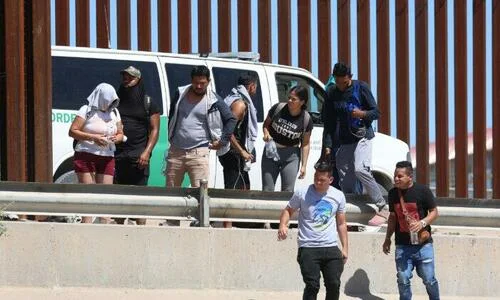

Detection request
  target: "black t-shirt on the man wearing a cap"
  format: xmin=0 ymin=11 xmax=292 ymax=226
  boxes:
xmin=115 ymin=81 xmax=160 ymax=158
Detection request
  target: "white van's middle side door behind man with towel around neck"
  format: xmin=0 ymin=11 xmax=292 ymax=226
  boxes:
xmin=207 ymin=60 xmax=271 ymax=190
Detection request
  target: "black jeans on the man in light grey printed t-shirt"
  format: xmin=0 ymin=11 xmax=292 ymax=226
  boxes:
xmin=297 ymin=247 xmax=344 ymax=300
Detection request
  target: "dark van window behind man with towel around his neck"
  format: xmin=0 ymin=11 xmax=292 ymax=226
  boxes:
xmin=212 ymin=67 xmax=264 ymax=122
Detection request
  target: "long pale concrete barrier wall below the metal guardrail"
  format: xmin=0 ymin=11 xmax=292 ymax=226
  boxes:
xmin=0 ymin=223 xmax=500 ymax=296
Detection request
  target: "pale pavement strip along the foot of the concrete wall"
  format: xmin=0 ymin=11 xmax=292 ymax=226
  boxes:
xmin=0 ymin=287 xmax=500 ymax=300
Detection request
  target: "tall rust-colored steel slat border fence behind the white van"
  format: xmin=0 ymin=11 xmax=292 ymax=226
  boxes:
xmin=0 ymin=0 xmax=500 ymax=199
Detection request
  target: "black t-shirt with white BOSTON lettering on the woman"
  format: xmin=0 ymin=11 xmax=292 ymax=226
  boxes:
xmin=267 ymin=104 xmax=313 ymax=146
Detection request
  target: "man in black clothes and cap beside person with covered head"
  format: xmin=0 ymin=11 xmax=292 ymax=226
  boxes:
xmin=115 ymin=66 xmax=160 ymax=225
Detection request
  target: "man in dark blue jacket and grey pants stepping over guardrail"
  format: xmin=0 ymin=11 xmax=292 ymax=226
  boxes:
xmin=323 ymin=63 xmax=389 ymax=226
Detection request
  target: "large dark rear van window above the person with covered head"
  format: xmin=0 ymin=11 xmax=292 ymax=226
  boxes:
xmin=52 ymin=56 xmax=163 ymax=114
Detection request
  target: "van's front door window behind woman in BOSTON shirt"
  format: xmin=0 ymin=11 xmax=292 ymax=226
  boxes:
xmin=275 ymin=73 xmax=326 ymax=125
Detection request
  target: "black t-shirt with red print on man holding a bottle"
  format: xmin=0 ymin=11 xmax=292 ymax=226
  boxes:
xmin=388 ymin=183 xmax=436 ymax=245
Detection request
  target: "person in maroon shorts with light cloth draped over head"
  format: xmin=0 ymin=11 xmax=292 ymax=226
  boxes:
xmin=69 ymin=83 xmax=123 ymax=223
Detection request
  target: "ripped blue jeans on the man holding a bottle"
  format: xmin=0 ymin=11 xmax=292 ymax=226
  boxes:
xmin=395 ymin=243 xmax=439 ymax=300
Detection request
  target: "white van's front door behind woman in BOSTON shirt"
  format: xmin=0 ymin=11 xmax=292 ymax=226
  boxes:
xmin=266 ymin=66 xmax=326 ymax=190
